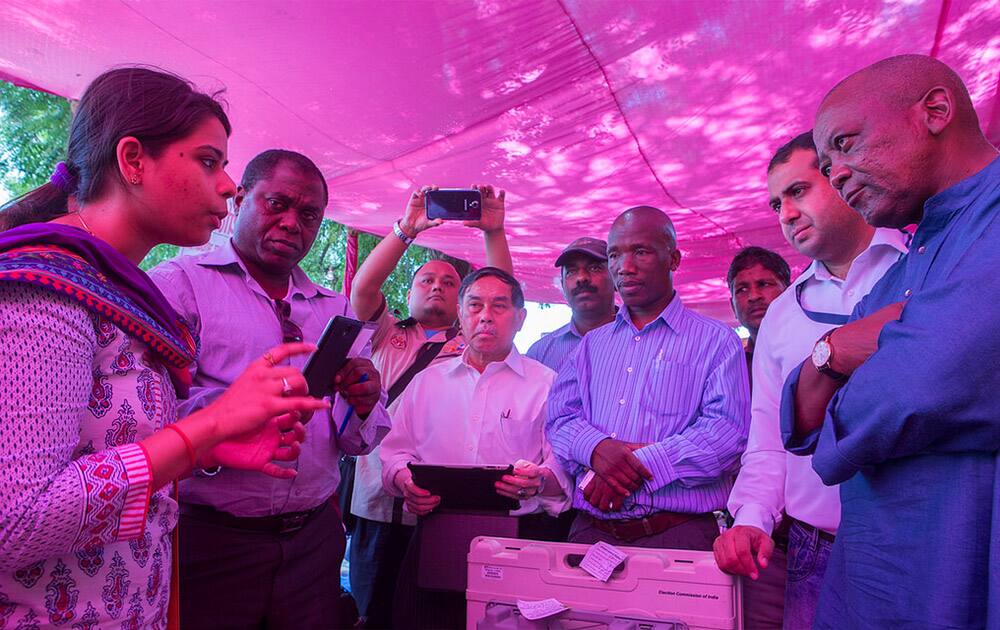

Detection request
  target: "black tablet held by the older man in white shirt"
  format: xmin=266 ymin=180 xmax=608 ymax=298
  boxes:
xmin=407 ymin=462 xmax=520 ymax=512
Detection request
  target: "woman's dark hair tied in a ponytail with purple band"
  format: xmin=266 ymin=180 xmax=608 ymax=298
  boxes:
xmin=0 ymin=67 xmax=232 ymax=228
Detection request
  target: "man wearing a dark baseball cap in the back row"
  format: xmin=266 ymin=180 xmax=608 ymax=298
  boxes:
xmin=527 ymin=236 xmax=616 ymax=372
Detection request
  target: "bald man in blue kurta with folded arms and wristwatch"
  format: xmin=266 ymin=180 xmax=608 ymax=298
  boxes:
xmin=782 ymin=55 xmax=1000 ymax=629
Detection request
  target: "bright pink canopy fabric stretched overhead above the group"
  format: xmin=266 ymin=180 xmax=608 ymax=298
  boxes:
xmin=0 ymin=0 xmax=1000 ymax=321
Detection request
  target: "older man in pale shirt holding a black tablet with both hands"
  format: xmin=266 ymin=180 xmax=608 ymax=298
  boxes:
xmin=380 ymin=267 xmax=572 ymax=628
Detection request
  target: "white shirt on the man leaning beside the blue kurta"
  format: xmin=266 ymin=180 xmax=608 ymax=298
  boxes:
xmin=728 ymin=229 xmax=907 ymax=534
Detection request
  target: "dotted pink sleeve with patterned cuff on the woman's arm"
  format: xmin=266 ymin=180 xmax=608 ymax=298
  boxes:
xmin=0 ymin=283 xmax=152 ymax=572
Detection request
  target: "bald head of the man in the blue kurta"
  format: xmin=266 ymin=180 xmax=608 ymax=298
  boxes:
xmin=813 ymin=55 xmax=996 ymax=228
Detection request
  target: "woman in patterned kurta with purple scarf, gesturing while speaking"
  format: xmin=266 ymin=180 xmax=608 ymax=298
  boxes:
xmin=0 ymin=68 xmax=325 ymax=629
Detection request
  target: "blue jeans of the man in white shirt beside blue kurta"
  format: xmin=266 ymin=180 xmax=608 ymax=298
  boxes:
xmin=784 ymin=523 xmax=833 ymax=630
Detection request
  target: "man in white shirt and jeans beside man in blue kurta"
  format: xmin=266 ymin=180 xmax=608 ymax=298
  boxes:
xmin=715 ymin=132 xmax=906 ymax=630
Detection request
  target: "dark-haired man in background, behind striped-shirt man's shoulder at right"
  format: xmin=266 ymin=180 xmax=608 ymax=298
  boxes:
xmin=726 ymin=246 xmax=792 ymax=389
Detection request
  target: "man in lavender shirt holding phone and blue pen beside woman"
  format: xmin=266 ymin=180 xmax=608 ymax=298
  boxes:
xmin=151 ymin=150 xmax=390 ymax=629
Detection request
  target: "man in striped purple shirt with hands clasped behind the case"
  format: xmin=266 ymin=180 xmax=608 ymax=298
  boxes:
xmin=546 ymin=206 xmax=750 ymax=551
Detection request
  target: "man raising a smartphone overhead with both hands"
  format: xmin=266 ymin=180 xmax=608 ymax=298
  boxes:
xmin=350 ymin=185 xmax=513 ymax=628
